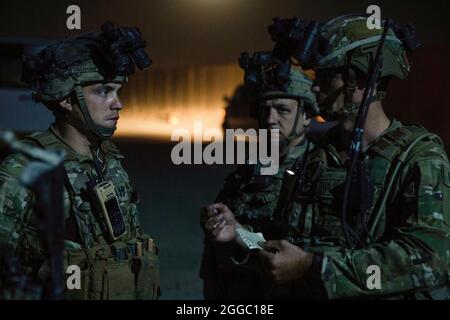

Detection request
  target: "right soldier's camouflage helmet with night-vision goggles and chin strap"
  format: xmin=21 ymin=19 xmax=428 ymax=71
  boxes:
xmin=269 ymin=14 xmax=420 ymax=120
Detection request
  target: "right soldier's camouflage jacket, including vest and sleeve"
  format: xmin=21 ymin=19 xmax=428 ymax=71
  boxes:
xmin=298 ymin=120 xmax=450 ymax=299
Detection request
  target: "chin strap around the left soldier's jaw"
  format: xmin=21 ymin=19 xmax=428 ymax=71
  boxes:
xmin=68 ymin=85 xmax=115 ymax=144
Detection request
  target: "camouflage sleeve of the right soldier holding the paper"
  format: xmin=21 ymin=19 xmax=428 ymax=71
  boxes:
xmin=320 ymin=157 xmax=450 ymax=299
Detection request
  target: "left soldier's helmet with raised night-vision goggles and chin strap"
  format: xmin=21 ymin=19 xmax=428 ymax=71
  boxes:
xmin=22 ymin=22 xmax=151 ymax=140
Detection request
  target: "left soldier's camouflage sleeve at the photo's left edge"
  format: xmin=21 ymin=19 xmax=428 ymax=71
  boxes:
xmin=0 ymin=155 xmax=32 ymax=247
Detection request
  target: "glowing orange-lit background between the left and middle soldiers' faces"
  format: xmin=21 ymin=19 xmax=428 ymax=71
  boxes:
xmin=117 ymin=64 xmax=242 ymax=140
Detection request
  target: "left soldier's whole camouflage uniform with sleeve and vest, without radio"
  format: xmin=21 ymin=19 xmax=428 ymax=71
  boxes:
xmin=0 ymin=127 xmax=159 ymax=299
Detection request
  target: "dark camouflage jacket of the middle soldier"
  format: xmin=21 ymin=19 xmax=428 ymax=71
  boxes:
xmin=200 ymin=141 xmax=308 ymax=299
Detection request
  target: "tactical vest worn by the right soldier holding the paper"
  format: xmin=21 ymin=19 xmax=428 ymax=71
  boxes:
xmin=289 ymin=122 xmax=442 ymax=251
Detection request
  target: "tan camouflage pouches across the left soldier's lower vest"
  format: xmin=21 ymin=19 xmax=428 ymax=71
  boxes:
xmin=64 ymin=236 xmax=159 ymax=300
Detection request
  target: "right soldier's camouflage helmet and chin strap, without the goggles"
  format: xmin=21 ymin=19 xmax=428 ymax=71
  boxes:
xmin=314 ymin=15 xmax=419 ymax=120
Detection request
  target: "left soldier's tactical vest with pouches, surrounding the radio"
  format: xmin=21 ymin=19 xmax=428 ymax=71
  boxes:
xmin=18 ymin=132 xmax=159 ymax=300
